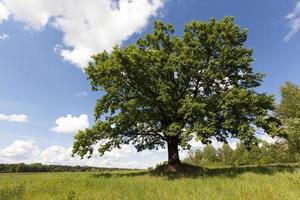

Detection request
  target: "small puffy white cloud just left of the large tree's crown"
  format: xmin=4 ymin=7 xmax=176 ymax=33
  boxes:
xmin=51 ymin=114 xmax=89 ymax=133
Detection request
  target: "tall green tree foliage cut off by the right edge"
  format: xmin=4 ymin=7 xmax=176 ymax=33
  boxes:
xmin=276 ymin=83 xmax=300 ymax=154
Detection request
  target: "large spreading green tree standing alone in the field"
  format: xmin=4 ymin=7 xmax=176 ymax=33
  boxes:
xmin=73 ymin=17 xmax=276 ymax=165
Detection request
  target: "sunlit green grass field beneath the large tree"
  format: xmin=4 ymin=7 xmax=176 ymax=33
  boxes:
xmin=0 ymin=165 xmax=300 ymax=200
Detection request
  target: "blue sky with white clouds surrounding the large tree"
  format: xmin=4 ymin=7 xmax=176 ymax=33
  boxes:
xmin=0 ymin=0 xmax=300 ymax=168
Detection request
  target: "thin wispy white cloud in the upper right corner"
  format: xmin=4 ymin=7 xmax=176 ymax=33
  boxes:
xmin=284 ymin=1 xmax=300 ymax=42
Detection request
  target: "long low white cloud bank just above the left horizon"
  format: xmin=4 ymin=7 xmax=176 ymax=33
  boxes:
xmin=0 ymin=140 xmax=167 ymax=168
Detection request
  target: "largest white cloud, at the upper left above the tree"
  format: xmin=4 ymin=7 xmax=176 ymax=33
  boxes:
xmin=2 ymin=0 xmax=165 ymax=68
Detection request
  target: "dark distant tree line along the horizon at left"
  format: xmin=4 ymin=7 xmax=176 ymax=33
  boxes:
xmin=0 ymin=163 xmax=132 ymax=173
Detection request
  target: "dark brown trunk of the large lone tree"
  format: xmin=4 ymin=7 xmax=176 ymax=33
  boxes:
xmin=168 ymin=136 xmax=181 ymax=166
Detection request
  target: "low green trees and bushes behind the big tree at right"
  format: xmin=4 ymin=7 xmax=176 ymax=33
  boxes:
xmin=184 ymin=141 xmax=300 ymax=166
